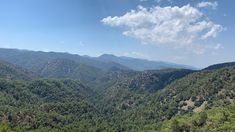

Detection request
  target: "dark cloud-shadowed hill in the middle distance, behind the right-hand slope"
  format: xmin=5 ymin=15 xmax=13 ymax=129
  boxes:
xmin=114 ymin=69 xmax=194 ymax=92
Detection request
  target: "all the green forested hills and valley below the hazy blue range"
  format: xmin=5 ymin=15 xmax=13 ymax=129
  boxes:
xmin=0 ymin=51 xmax=235 ymax=132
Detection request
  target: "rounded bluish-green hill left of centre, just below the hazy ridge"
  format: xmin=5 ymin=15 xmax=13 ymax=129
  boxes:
xmin=36 ymin=59 xmax=104 ymax=82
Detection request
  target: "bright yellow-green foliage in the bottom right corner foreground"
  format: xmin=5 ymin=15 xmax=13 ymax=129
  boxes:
xmin=159 ymin=104 xmax=235 ymax=132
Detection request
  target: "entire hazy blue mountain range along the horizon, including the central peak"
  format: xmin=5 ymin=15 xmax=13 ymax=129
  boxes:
xmin=0 ymin=48 xmax=195 ymax=71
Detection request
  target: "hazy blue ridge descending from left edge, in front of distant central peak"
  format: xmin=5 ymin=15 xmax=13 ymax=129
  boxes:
xmin=0 ymin=48 xmax=128 ymax=70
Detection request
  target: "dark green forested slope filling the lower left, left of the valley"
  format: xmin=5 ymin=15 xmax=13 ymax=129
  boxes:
xmin=0 ymin=79 xmax=115 ymax=131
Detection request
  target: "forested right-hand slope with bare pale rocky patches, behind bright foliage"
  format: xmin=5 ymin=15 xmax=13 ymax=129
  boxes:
xmin=100 ymin=67 xmax=235 ymax=131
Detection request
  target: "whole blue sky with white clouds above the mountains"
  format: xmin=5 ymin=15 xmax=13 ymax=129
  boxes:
xmin=0 ymin=0 xmax=235 ymax=67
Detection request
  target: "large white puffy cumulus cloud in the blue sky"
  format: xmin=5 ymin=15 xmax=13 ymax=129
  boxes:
xmin=101 ymin=4 xmax=224 ymax=54
